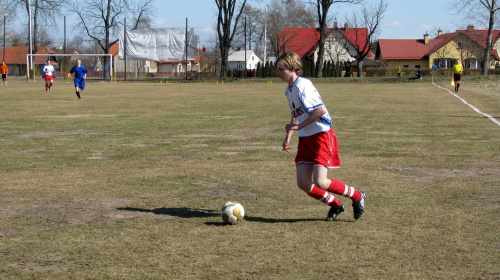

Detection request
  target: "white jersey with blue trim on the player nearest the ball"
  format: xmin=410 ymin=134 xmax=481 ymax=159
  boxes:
xmin=285 ymin=77 xmax=332 ymax=137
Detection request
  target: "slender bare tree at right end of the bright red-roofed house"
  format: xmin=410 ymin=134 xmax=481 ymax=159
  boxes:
xmin=346 ymin=0 xmax=388 ymax=77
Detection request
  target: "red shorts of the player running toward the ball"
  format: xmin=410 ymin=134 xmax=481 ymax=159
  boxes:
xmin=295 ymin=128 xmax=340 ymax=168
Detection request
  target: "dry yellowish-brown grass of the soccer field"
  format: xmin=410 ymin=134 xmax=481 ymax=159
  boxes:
xmin=0 ymin=77 xmax=500 ymax=279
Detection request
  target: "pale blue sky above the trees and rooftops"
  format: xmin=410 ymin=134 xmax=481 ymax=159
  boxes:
xmin=155 ymin=0 xmax=470 ymax=44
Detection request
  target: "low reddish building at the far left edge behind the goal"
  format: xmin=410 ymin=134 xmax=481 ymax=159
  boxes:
xmin=0 ymin=46 xmax=57 ymax=76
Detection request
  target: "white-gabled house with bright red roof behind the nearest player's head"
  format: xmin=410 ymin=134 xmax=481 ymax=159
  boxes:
xmin=279 ymin=22 xmax=373 ymax=67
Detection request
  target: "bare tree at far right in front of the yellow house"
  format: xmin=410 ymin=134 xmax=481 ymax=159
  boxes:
xmin=452 ymin=0 xmax=500 ymax=75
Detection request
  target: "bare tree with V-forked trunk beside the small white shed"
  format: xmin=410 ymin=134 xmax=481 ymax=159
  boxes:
xmin=215 ymin=0 xmax=247 ymax=78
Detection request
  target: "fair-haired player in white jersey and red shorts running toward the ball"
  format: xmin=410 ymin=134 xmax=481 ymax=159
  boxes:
xmin=277 ymin=52 xmax=365 ymax=221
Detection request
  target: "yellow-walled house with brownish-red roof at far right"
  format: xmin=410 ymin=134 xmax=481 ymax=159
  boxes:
xmin=376 ymin=25 xmax=500 ymax=70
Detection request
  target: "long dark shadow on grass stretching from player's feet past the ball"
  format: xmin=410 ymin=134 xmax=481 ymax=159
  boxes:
xmin=117 ymin=207 xmax=350 ymax=225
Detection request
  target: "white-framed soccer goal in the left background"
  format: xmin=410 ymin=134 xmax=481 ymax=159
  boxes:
xmin=26 ymin=53 xmax=114 ymax=82
